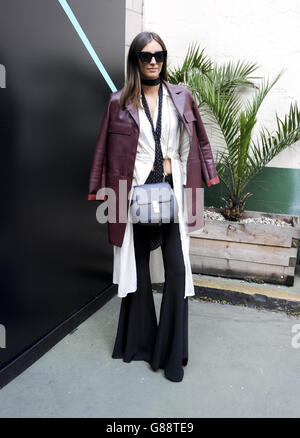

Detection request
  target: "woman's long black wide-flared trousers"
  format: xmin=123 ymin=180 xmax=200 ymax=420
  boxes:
xmin=112 ymin=219 xmax=188 ymax=382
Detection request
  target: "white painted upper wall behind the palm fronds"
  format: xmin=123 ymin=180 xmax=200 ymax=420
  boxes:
xmin=143 ymin=0 xmax=300 ymax=169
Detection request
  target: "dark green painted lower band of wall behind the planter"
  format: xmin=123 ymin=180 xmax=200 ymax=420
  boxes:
xmin=204 ymin=167 xmax=300 ymax=264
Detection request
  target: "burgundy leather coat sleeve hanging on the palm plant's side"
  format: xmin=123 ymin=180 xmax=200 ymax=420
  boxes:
xmin=191 ymin=94 xmax=220 ymax=187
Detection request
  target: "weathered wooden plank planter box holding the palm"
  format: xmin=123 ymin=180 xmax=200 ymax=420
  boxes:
xmin=190 ymin=207 xmax=300 ymax=286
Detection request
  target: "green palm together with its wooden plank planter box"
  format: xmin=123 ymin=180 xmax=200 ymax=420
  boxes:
xmin=168 ymin=45 xmax=300 ymax=285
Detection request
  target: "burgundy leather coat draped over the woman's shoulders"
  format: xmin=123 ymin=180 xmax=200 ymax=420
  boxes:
xmin=88 ymin=80 xmax=220 ymax=247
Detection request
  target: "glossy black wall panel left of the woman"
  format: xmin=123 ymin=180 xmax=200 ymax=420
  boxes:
xmin=0 ymin=0 xmax=125 ymax=371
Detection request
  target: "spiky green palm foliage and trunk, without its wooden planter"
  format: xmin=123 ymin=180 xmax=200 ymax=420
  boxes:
xmin=168 ymin=44 xmax=300 ymax=220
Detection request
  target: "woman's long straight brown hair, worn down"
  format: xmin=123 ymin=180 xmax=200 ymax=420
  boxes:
xmin=119 ymin=32 xmax=168 ymax=109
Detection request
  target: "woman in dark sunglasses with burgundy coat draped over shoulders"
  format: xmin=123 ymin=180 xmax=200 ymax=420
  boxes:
xmin=89 ymin=32 xmax=219 ymax=382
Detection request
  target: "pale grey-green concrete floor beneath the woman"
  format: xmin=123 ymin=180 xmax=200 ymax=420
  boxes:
xmin=0 ymin=293 xmax=300 ymax=418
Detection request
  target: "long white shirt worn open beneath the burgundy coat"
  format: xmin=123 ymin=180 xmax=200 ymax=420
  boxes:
xmin=113 ymin=85 xmax=195 ymax=298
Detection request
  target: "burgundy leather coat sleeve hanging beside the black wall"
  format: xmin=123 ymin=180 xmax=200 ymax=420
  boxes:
xmin=88 ymin=94 xmax=112 ymax=201
